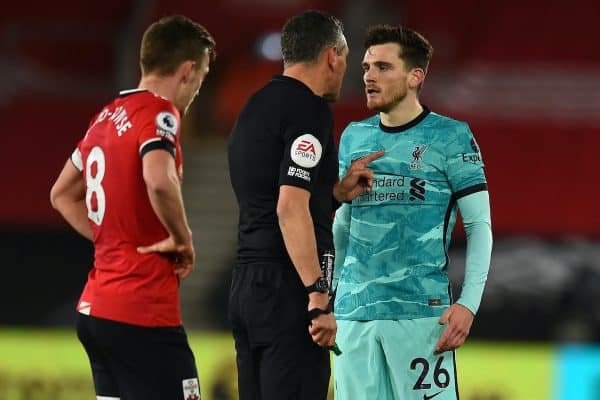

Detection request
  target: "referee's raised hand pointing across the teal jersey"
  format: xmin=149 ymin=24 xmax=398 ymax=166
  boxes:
xmin=333 ymin=150 xmax=385 ymax=202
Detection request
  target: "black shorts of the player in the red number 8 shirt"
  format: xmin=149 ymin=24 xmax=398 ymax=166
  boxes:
xmin=77 ymin=314 xmax=200 ymax=400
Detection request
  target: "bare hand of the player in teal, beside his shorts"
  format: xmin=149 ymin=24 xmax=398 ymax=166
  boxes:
xmin=433 ymin=303 xmax=475 ymax=354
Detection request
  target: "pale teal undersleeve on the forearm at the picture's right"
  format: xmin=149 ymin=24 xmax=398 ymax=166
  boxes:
xmin=457 ymin=191 xmax=492 ymax=314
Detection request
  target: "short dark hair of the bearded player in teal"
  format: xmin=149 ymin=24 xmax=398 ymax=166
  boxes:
xmin=365 ymin=25 xmax=433 ymax=72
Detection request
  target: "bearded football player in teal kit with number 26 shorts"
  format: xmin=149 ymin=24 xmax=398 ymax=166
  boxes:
xmin=334 ymin=25 xmax=492 ymax=400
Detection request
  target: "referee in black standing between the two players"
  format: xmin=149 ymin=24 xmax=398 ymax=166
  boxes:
xmin=229 ymin=11 xmax=383 ymax=400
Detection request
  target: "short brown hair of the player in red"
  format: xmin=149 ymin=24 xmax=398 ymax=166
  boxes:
xmin=140 ymin=15 xmax=216 ymax=75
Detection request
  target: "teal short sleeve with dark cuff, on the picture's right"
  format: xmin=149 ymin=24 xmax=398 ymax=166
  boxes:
xmin=446 ymin=122 xmax=487 ymax=198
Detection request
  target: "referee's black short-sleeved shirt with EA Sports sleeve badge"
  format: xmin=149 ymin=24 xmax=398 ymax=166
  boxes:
xmin=229 ymin=75 xmax=338 ymax=263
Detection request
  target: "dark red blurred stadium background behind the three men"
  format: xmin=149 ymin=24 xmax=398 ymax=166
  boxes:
xmin=0 ymin=0 xmax=600 ymax=342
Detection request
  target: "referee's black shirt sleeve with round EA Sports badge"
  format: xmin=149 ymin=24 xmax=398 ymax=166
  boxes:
xmin=279 ymin=100 xmax=333 ymax=192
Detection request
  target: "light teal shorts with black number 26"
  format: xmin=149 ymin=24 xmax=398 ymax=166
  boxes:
xmin=333 ymin=317 xmax=458 ymax=400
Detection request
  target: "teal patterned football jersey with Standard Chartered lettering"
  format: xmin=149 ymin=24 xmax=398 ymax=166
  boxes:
xmin=335 ymin=109 xmax=487 ymax=320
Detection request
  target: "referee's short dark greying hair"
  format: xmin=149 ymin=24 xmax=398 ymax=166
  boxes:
xmin=281 ymin=10 xmax=346 ymax=67
